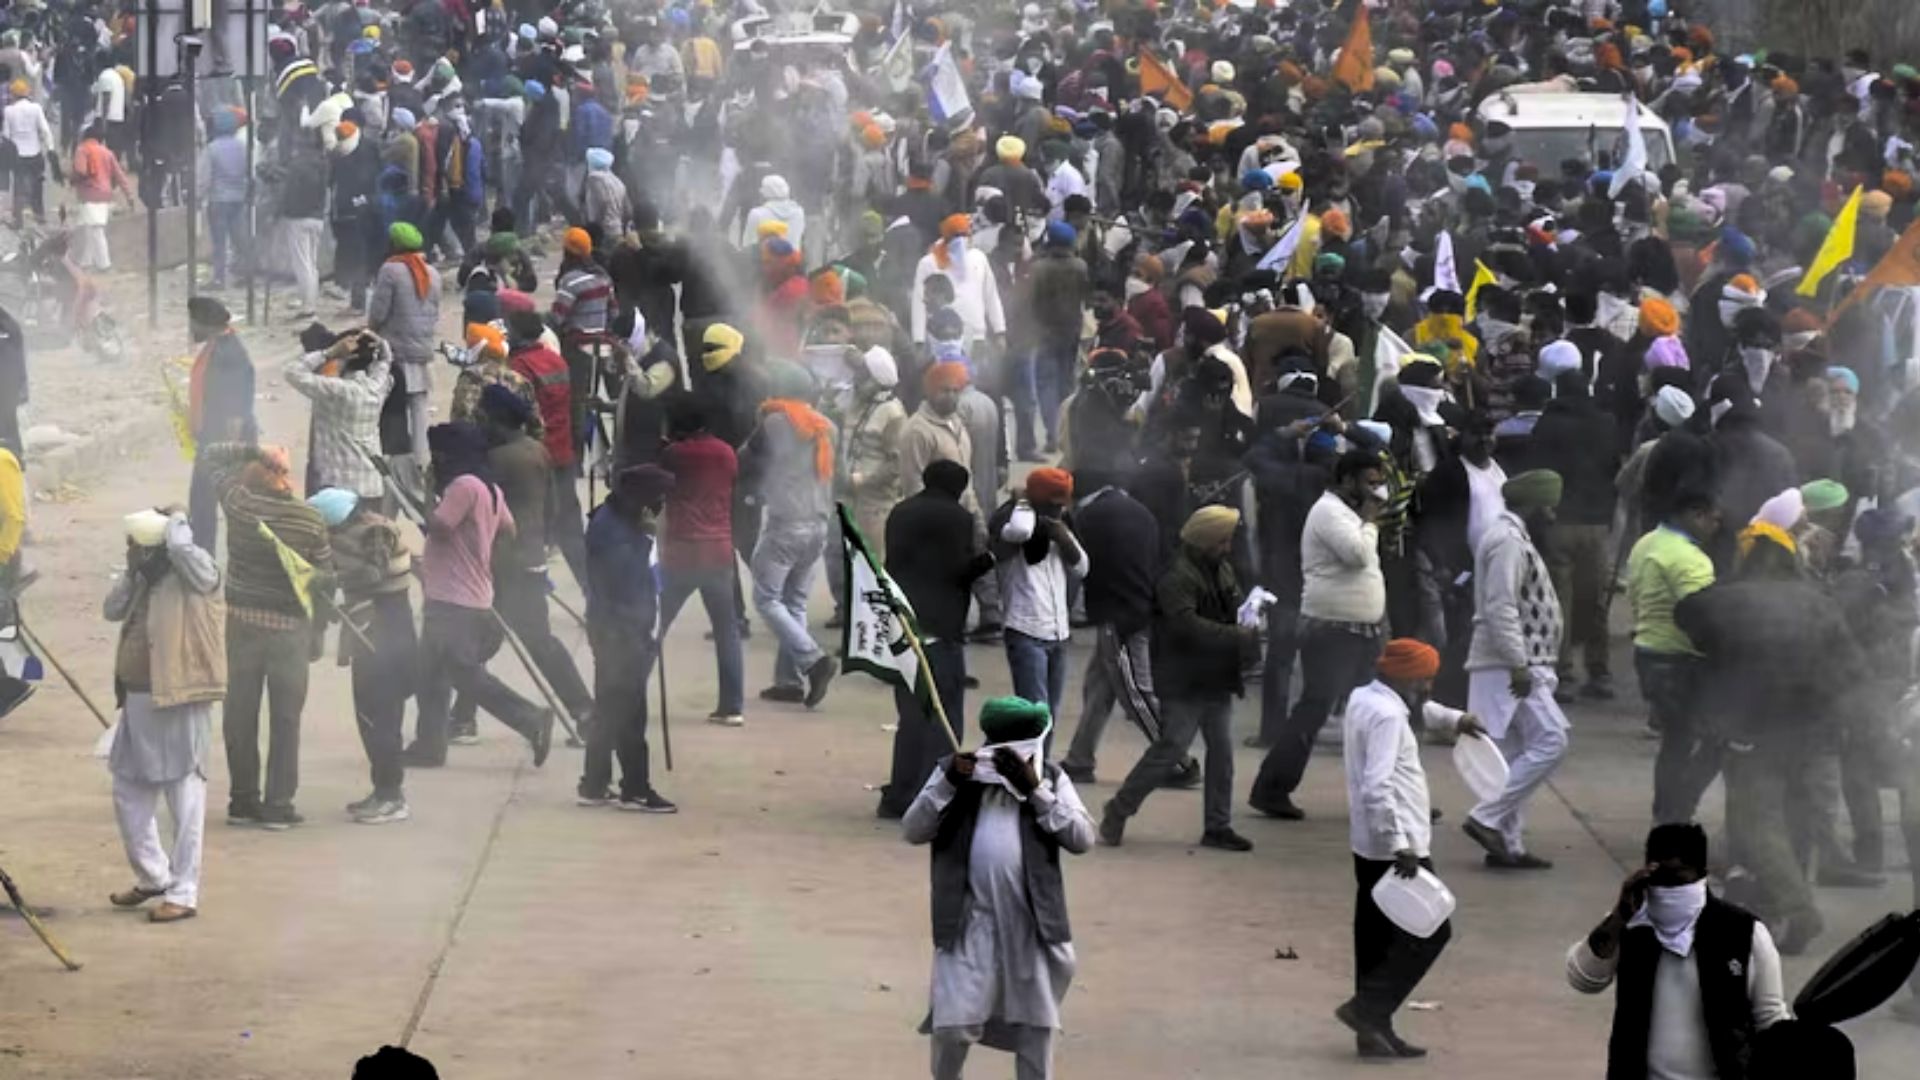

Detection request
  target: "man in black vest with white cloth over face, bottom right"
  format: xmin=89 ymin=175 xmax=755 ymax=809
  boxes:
xmin=1567 ymin=824 xmax=1789 ymax=1076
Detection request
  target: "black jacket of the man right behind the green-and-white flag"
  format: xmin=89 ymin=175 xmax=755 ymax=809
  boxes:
xmin=887 ymin=488 xmax=993 ymax=640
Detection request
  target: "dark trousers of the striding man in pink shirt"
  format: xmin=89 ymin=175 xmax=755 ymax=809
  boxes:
xmin=415 ymin=600 xmax=545 ymax=761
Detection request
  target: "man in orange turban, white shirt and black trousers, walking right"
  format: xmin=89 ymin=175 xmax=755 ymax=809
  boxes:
xmin=1334 ymin=638 xmax=1486 ymax=1059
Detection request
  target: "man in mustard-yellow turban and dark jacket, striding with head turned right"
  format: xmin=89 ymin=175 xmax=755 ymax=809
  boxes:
xmin=1100 ymin=505 xmax=1260 ymax=851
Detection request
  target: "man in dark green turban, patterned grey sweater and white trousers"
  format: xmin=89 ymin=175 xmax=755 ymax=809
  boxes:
xmin=1461 ymin=469 xmax=1567 ymax=871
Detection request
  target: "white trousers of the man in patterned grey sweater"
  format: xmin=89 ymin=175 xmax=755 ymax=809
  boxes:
xmin=1467 ymin=667 xmax=1567 ymax=855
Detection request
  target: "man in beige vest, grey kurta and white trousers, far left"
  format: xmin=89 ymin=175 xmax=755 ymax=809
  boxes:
xmin=104 ymin=509 xmax=227 ymax=922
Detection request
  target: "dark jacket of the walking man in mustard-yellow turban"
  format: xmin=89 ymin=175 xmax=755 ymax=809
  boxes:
xmin=1154 ymin=544 xmax=1258 ymax=698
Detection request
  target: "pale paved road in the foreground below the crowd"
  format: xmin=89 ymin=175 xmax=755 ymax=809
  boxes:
xmin=0 ymin=282 xmax=1920 ymax=1080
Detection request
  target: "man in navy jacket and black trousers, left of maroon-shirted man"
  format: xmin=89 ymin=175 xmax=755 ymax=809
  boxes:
xmin=580 ymin=465 xmax=680 ymax=813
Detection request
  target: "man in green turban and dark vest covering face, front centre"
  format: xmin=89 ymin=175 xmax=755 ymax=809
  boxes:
xmin=900 ymin=698 xmax=1092 ymax=1080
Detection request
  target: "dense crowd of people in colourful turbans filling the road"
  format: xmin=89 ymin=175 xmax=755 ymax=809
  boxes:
xmin=0 ymin=0 xmax=1920 ymax=1078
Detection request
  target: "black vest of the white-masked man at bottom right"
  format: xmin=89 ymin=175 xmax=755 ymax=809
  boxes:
xmin=1607 ymin=896 xmax=1755 ymax=1080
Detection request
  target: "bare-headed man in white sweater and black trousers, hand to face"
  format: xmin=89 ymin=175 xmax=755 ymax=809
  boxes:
xmin=1248 ymin=450 xmax=1390 ymax=821
